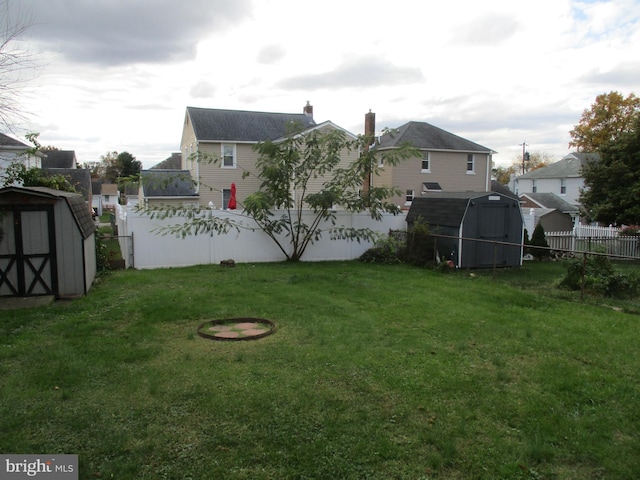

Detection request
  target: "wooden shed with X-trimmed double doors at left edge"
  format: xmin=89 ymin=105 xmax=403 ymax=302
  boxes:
xmin=0 ymin=187 xmax=97 ymax=298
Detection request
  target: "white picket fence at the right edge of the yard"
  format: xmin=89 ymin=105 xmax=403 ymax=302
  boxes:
xmin=545 ymin=225 xmax=640 ymax=258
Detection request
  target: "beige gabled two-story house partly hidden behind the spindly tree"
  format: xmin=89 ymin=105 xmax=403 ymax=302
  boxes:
xmin=180 ymin=103 xmax=359 ymax=209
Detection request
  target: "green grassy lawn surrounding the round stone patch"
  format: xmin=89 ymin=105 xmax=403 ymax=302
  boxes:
xmin=0 ymin=262 xmax=640 ymax=480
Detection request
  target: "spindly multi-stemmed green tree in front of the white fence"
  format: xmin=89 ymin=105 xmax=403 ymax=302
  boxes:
xmin=150 ymin=126 xmax=420 ymax=261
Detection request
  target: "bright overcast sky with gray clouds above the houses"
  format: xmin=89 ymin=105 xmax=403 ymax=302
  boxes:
xmin=8 ymin=0 xmax=640 ymax=168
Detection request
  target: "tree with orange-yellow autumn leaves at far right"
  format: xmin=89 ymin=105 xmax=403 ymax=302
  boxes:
xmin=569 ymin=91 xmax=640 ymax=153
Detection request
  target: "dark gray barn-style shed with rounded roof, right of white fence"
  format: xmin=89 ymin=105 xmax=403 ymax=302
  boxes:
xmin=407 ymin=192 xmax=524 ymax=268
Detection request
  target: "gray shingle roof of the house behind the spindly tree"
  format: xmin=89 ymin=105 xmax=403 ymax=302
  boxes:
xmin=187 ymin=107 xmax=316 ymax=142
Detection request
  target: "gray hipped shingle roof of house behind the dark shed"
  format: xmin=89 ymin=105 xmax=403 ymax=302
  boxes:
xmin=377 ymin=122 xmax=493 ymax=153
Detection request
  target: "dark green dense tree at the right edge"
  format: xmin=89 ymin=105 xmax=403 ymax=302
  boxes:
xmin=580 ymin=116 xmax=640 ymax=225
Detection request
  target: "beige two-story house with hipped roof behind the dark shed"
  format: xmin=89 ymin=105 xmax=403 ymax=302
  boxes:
xmin=371 ymin=122 xmax=496 ymax=209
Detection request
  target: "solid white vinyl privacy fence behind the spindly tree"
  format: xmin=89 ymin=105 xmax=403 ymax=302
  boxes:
xmin=116 ymin=206 xmax=406 ymax=269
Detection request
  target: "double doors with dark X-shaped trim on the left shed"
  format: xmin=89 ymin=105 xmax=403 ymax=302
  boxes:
xmin=0 ymin=206 xmax=57 ymax=297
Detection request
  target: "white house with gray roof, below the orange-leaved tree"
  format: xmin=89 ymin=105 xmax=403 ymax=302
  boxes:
xmin=510 ymin=153 xmax=600 ymax=208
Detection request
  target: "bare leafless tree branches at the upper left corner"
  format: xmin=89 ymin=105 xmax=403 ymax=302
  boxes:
xmin=0 ymin=0 xmax=36 ymax=131
